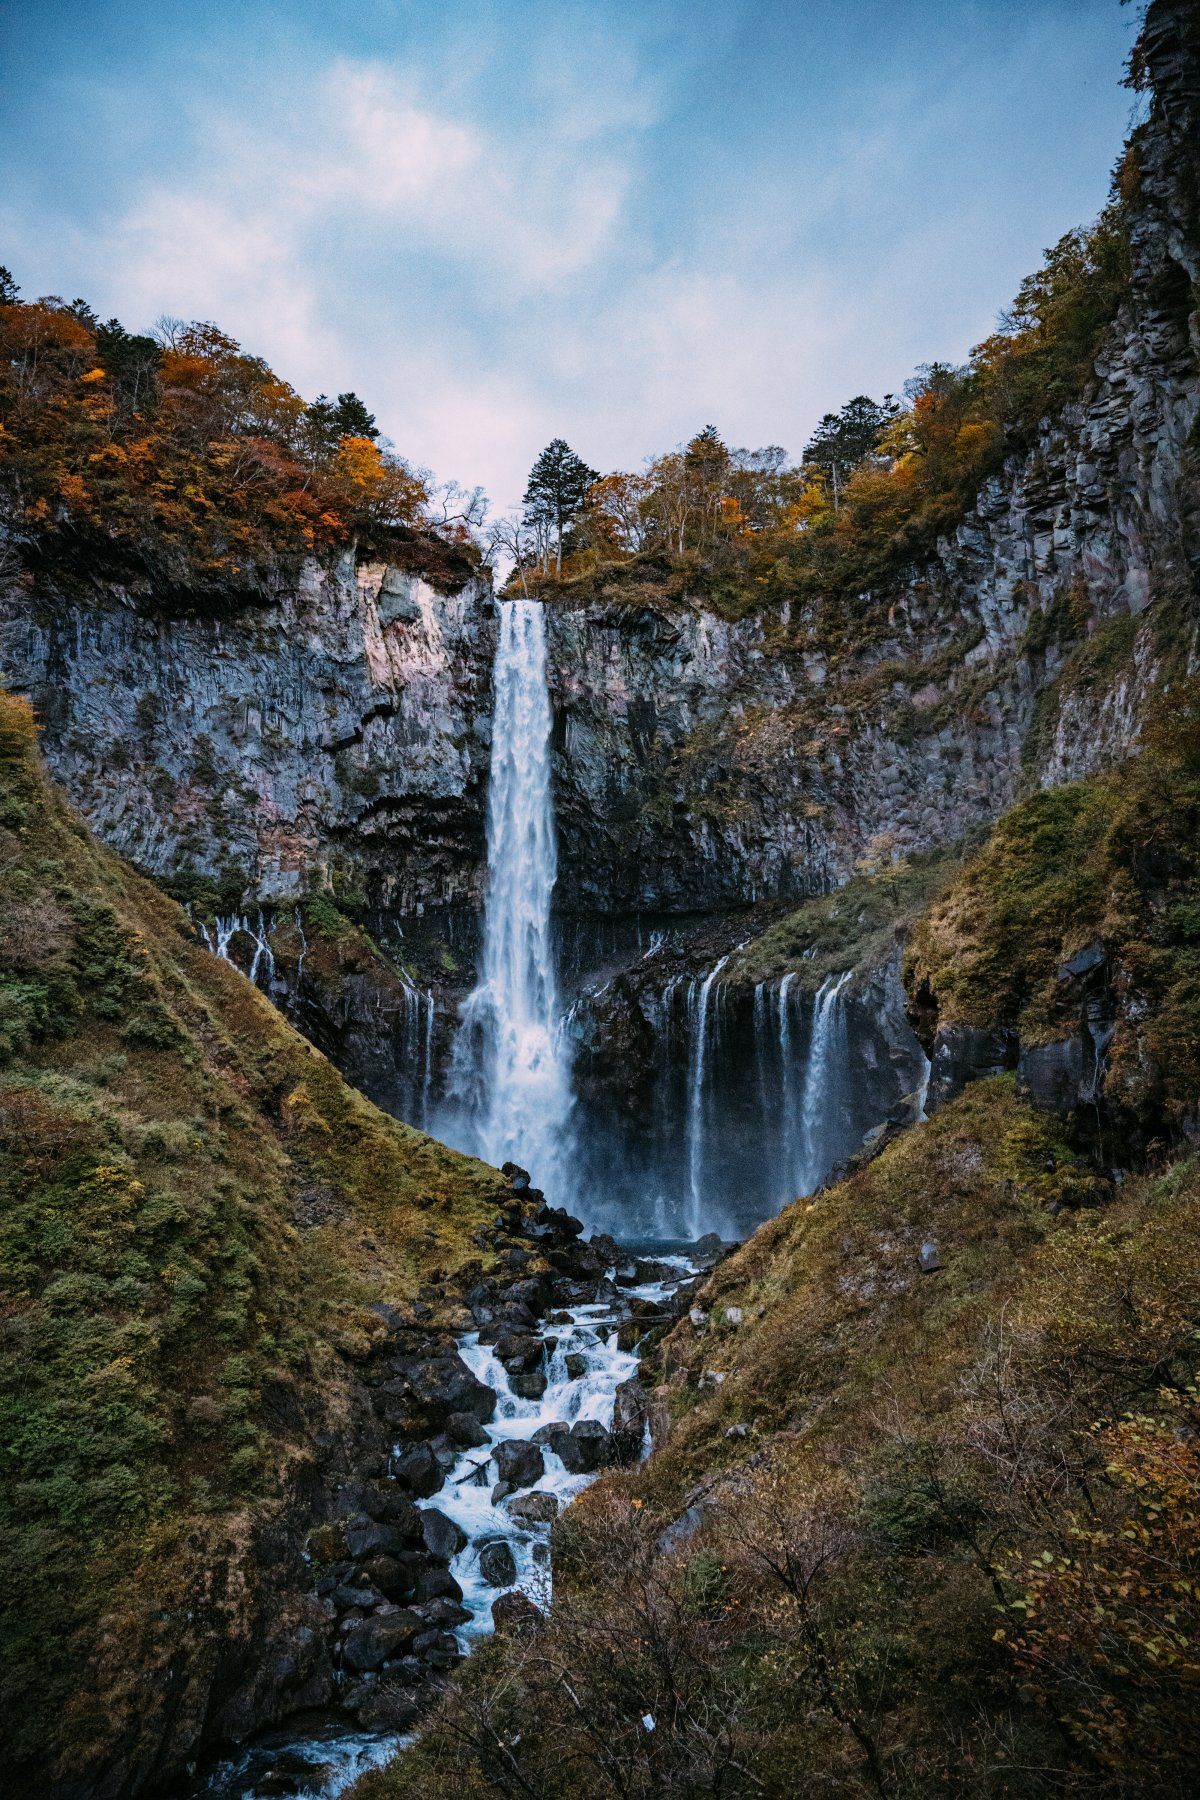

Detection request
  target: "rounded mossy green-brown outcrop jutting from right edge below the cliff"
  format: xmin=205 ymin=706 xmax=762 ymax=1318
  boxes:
xmin=905 ymin=682 xmax=1200 ymax=1127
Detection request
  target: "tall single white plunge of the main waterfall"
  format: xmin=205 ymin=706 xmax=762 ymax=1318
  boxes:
xmin=450 ymin=599 xmax=572 ymax=1199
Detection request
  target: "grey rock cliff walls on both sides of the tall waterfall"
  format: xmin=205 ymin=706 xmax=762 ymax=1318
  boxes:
xmin=0 ymin=7 xmax=1200 ymax=1224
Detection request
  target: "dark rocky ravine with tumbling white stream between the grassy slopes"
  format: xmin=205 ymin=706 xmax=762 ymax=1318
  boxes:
xmin=184 ymin=1170 xmax=698 ymax=1791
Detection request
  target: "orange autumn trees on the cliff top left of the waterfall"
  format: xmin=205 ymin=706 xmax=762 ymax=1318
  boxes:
xmin=0 ymin=280 xmax=482 ymax=607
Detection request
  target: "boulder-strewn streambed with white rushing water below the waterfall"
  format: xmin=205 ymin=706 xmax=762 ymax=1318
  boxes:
xmin=193 ymin=1165 xmax=708 ymax=1800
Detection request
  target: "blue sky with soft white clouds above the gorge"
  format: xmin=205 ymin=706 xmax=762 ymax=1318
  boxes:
xmin=0 ymin=0 xmax=1137 ymax=511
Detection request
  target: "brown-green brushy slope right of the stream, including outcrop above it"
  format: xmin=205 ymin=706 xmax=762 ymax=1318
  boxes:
xmin=358 ymin=709 xmax=1200 ymax=1800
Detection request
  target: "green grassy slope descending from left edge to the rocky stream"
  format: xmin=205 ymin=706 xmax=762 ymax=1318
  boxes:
xmin=0 ymin=697 xmax=507 ymax=1766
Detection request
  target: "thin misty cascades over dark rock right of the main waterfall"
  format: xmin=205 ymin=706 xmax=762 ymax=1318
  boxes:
xmin=574 ymin=968 xmax=925 ymax=1242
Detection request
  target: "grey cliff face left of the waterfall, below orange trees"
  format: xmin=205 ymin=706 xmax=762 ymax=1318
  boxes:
xmin=0 ymin=554 xmax=495 ymax=913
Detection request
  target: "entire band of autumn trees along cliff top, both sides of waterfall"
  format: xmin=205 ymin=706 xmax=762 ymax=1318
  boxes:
xmin=0 ymin=174 xmax=1137 ymax=610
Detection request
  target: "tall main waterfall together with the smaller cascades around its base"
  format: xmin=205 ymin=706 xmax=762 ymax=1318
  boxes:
xmin=198 ymin=599 xmax=928 ymax=1242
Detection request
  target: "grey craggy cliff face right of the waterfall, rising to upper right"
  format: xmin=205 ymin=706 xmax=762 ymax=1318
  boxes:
xmin=551 ymin=58 xmax=1200 ymax=913
